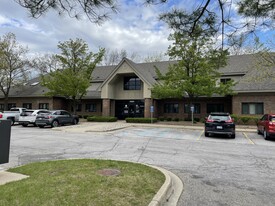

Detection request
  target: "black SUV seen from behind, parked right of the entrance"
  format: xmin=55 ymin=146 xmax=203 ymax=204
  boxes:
xmin=204 ymin=113 xmax=236 ymax=138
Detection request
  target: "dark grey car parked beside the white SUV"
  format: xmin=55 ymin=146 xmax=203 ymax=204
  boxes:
xmin=35 ymin=110 xmax=79 ymax=128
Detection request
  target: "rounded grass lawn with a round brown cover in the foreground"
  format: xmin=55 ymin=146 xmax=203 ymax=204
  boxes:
xmin=0 ymin=159 xmax=165 ymax=206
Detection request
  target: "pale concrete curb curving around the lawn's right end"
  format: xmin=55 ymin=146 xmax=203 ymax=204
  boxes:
xmin=148 ymin=165 xmax=183 ymax=206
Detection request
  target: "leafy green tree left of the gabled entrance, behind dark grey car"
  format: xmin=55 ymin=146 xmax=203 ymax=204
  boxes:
xmin=42 ymin=39 xmax=104 ymax=113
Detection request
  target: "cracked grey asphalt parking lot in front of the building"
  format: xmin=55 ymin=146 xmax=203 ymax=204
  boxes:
xmin=0 ymin=124 xmax=275 ymax=206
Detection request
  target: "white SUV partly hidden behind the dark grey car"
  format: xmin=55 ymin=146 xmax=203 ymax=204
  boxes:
xmin=18 ymin=109 xmax=50 ymax=127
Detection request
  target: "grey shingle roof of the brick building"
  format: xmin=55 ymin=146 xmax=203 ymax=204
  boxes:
xmin=1 ymin=55 xmax=275 ymax=99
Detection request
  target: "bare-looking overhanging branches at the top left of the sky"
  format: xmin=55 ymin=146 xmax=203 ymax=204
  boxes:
xmin=15 ymin=0 xmax=117 ymax=24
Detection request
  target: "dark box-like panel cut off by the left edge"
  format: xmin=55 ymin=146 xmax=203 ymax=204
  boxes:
xmin=0 ymin=120 xmax=11 ymax=164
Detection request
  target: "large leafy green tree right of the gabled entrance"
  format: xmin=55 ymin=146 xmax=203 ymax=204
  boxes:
xmin=152 ymin=28 xmax=233 ymax=116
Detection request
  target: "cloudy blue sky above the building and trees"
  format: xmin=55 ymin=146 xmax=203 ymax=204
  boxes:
xmin=0 ymin=0 xmax=274 ymax=61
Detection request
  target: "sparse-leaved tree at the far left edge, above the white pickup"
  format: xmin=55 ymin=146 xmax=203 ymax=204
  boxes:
xmin=0 ymin=33 xmax=30 ymax=110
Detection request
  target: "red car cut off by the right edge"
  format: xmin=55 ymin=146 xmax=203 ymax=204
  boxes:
xmin=257 ymin=114 xmax=275 ymax=140
